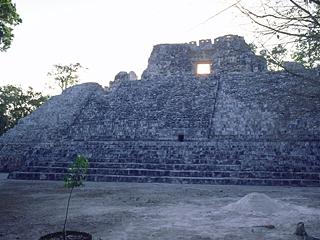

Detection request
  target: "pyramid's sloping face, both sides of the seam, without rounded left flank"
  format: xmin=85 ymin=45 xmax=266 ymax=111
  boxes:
xmin=69 ymin=71 xmax=320 ymax=140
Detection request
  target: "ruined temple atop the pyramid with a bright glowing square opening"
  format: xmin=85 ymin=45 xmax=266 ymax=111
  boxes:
xmin=142 ymin=35 xmax=267 ymax=79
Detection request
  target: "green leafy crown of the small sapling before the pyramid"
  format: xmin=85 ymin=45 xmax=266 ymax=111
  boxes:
xmin=64 ymin=155 xmax=89 ymax=188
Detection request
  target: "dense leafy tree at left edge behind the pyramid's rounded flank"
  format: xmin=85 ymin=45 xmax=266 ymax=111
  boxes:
xmin=0 ymin=85 xmax=48 ymax=135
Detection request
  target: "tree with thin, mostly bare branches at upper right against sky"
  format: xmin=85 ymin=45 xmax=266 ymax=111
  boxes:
xmin=238 ymin=0 xmax=320 ymax=68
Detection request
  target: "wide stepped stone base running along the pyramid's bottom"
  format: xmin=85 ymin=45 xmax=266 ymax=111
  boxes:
xmin=9 ymin=140 xmax=320 ymax=186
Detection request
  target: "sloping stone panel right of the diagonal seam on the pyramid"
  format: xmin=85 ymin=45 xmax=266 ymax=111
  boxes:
xmin=213 ymin=71 xmax=320 ymax=139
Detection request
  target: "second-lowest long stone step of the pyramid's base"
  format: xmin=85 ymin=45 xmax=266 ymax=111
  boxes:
xmin=25 ymin=167 xmax=320 ymax=180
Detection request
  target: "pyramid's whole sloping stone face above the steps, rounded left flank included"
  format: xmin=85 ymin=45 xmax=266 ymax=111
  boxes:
xmin=0 ymin=67 xmax=320 ymax=170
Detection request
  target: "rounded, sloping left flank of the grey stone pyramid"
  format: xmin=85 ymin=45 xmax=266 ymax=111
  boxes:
xmin=0 ymin=83 xmax=103 ymax=171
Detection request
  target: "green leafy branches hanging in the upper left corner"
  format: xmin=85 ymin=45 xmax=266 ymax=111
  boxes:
xmin=0 ymin=0 xmax=22 ymax=51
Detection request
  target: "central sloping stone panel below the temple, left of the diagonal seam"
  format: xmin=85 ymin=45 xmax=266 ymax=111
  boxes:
xmin=70 ymin=75 xmax=217 ymax=140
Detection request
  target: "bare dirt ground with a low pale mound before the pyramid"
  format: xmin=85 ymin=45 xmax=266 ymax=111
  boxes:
xmin=0 ymin=174 xmax=320 ymax=240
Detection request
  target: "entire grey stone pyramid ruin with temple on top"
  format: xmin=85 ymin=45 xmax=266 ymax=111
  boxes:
xmin=0 ymin=35 xmax=320 ymax=186
